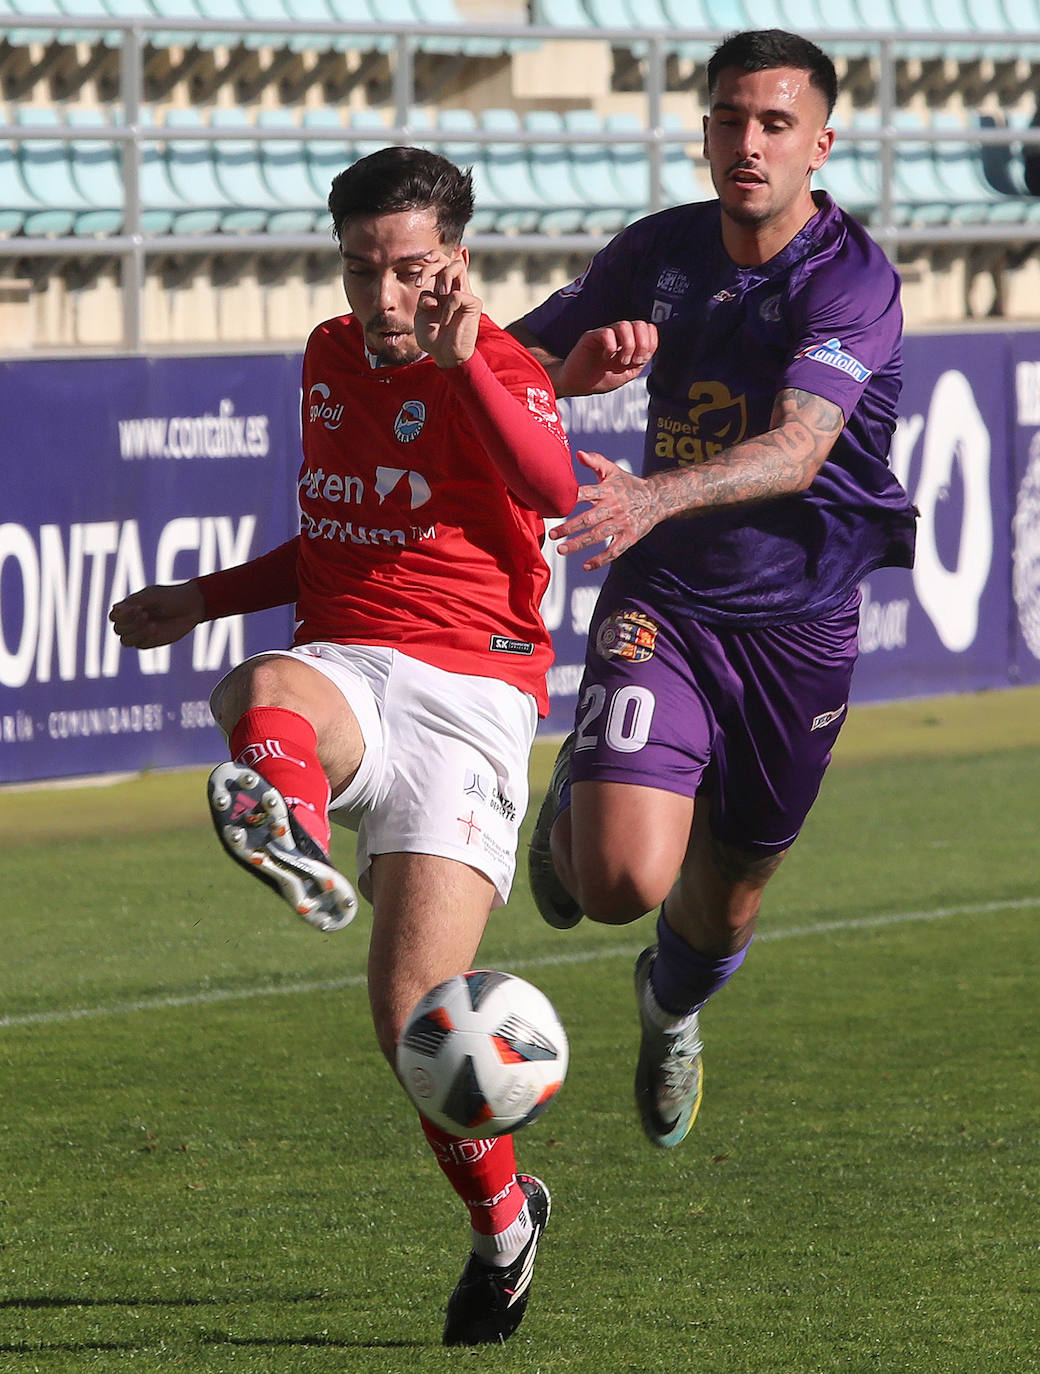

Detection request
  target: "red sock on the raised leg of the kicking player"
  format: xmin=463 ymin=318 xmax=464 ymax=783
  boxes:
xmin=228 ymin=706 xmax=331 ymax=853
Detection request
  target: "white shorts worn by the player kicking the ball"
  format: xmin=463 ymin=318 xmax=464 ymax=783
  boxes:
xmin=212 ymin=643 xmax=539 ymax=907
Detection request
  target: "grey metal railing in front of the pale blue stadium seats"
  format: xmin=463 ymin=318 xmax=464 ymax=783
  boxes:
xmin=0 ymin=14 xmax=1040 ymax=352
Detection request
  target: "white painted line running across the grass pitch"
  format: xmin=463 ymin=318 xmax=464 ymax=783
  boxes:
xmin=0 ymin=896 xmax=1040 ymax=1031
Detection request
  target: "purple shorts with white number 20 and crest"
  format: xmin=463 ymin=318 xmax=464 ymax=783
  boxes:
xmin=570 ymin=577 xmax=860 ymax=855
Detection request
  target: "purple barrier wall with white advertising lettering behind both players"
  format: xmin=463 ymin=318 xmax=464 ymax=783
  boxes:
xmin=0 ymin=331 xmax=1040 ymax=783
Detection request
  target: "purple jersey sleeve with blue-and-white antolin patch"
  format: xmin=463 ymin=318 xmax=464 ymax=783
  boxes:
xmin=779 ymin=237 xmax=903 ymax=423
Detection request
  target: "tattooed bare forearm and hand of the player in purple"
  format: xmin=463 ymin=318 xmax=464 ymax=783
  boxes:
xmin=550 ymin=387 xmax=845 ymax=572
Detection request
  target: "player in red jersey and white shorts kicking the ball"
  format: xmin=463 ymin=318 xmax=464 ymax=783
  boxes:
xmin=111 ymin=147 xmax=577 ymax=1345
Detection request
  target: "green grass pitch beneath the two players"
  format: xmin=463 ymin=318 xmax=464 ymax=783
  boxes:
xmin=0 ymin=690 xmax=1040 ymax=1374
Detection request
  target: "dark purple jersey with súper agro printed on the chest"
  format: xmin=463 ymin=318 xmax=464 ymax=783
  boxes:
xmin=525 ymin=192 xmax=915 ymax=625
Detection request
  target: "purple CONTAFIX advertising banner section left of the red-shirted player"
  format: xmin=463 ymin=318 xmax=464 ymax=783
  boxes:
xmin=0 ymin=356 xmax=299 ymax=782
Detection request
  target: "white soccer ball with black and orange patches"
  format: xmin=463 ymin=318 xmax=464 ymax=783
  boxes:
xmin=397 ymin=970 xmax=570 ymax=1139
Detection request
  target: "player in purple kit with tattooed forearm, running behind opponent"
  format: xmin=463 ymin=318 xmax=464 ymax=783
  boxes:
xmin=511 ymin=29 xmax=916 ymax=1147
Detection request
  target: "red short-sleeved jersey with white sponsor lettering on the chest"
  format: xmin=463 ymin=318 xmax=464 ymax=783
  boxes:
xmin=294 ymin=315 xmax=577 ymax=714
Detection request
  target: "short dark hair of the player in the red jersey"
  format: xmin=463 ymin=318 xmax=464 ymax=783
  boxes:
xmin=328 ymin=147 xmax=473 ymax=247
